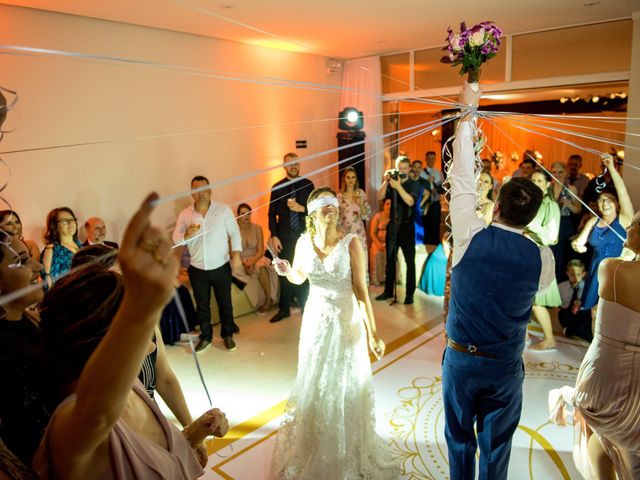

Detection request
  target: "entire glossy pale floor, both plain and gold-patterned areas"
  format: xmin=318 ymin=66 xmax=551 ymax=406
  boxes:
xmin=158 ymin=290 xmax=585 ymax=480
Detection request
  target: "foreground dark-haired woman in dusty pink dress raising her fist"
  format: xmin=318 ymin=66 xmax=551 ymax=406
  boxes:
xmin=32 ymin=194 xmax=229 ymax=480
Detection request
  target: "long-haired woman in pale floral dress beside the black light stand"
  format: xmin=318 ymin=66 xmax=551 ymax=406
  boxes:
xmin=337 ymin=167 xmax=371 ymax=258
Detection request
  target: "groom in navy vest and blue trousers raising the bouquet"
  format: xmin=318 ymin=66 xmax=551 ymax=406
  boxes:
xmin=442 ymin=83 xmax=554 ymax=480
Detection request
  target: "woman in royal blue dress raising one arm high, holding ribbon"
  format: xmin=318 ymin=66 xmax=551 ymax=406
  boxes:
xmin=572 ymin=154 xmax=633 ymax=318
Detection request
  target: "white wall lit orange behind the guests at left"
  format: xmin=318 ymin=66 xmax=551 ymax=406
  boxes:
xmin=0 ymin=5 xmax=340 ymax=248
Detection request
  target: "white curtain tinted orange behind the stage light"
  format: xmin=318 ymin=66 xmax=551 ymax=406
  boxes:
xmin=341 ymin=57 xmax=384 ymax=211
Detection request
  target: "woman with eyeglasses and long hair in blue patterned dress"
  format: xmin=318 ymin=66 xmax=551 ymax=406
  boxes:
xmin=42 ymin=207 xmax=82 ymax=288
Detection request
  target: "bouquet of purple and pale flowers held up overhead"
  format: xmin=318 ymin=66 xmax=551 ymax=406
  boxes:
xmin=440 ymin=22 xmax=502 ymax=83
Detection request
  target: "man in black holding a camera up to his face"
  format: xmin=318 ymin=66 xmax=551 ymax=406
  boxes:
xmin=376 ymin=157 xmax=420 ymax=305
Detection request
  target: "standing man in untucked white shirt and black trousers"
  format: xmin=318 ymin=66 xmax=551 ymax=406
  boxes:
xmin=173 ymin=175 xmax=242 ymax=352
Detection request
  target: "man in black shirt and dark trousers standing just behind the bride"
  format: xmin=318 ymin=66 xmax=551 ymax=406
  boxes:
xmin=269 ymin=153 xmax=314 ymax=323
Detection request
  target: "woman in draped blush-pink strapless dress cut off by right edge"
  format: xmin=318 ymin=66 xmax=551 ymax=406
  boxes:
xmin=574 ymin=209 xmax=640 ymax=480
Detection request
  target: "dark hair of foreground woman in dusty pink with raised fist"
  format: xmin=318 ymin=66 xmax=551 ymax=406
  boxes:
xmin=40 ymin=263 xmax=124 ymax=407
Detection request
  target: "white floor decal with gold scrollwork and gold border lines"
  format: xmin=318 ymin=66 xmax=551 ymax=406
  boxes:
xmin=203 ymin=323 xmax=586 ymax=480
